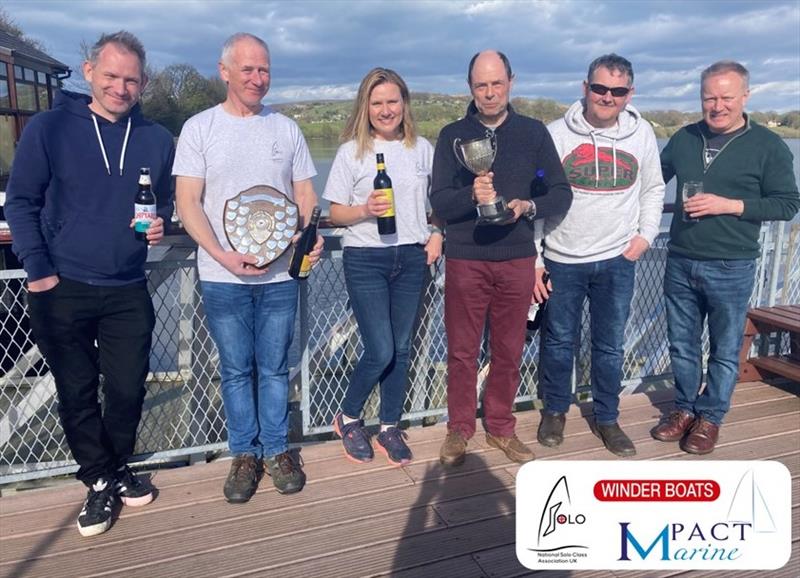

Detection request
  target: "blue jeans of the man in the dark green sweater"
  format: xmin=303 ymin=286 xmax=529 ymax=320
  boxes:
xmin=664 ymin=254 xmax=756 ymax=425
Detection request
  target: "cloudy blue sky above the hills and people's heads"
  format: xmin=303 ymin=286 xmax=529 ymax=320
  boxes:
xmin=0 ymin=0 xmax=800 ymax=111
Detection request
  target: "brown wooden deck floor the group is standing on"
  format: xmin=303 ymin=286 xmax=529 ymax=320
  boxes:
xmin=0 ymin=382 xmax=800 ymax=578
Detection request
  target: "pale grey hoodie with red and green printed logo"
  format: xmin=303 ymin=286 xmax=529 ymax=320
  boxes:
xmin=537 ymin=100 xmax=664 ymax=263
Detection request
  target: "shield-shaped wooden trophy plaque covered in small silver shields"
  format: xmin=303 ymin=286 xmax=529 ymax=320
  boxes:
xmin=223 ymin=185 xmax=298 ymax=267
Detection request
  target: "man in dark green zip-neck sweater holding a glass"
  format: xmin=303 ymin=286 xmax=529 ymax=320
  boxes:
xmin=652 ymin=61 xmax=800 ymax=454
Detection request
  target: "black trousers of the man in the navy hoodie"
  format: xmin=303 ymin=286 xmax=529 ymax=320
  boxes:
xmin=28 ymin=278 xmax=155 ymax=485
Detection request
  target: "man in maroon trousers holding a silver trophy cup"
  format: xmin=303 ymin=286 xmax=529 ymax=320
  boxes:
xmin=431 ymin=50 xmax=572 ymax=466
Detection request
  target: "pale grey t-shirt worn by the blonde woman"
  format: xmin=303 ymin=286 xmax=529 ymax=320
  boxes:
xmin=322 ymin=137 xmax=433 ymax=247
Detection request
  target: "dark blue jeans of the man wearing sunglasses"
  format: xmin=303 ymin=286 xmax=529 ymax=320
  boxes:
xmin=539 ymin=255 xmax=636 ymax=425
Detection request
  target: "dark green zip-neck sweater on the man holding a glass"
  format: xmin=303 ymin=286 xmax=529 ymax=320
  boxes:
xmin=661 ymin=115 xmax=800 ymax=260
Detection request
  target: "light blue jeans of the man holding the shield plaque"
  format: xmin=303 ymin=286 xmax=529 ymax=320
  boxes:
xmin=200 ymin=281 xmax=297 ymax=458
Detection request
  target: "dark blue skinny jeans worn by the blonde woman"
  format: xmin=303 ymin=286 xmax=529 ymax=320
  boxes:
xmin=342 ymin=245 xmax=427 ymax=424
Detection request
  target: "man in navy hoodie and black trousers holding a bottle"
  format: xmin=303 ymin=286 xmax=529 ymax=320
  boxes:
xmin=5 ymin=31 xmax=174 ymax=536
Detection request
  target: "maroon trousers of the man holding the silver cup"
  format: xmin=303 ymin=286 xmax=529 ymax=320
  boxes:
xmin=444 ymin=257 xmax=536 ymax=439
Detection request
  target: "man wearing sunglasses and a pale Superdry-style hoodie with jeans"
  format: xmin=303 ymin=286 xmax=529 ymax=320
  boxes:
xmin=533 ymin=54 xmax=664 ymax=457
